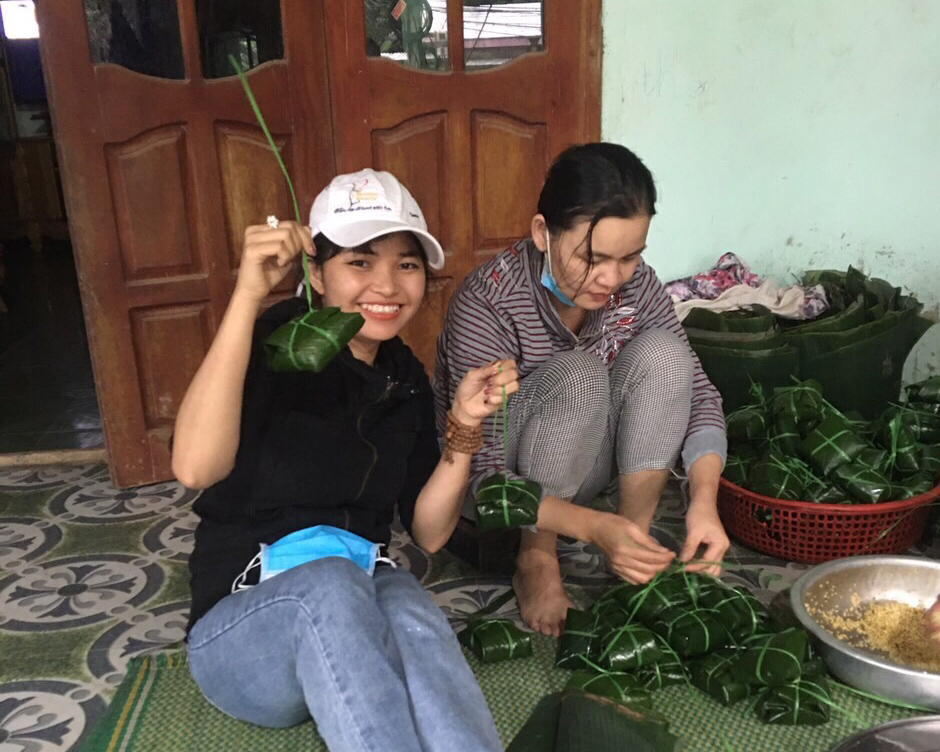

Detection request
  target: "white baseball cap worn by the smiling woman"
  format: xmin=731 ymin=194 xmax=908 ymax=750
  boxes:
xmin=310 ymin=169 xmax=444 ymax=269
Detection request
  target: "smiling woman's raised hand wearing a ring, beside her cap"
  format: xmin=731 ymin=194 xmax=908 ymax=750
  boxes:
xmin=235 ymin=221 xmax=313 ymax=302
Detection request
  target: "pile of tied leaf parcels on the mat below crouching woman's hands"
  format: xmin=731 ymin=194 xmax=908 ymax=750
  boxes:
xmin=556 ymin=569 xmax=832 ymax=725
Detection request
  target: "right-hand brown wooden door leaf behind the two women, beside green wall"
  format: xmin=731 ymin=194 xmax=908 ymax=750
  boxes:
xmin=324 ymin=0 xmax=602 ymax=368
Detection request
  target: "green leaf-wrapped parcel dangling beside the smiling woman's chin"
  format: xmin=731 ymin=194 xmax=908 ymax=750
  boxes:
xmin=264 ymin=308 xmax=365 ymax=372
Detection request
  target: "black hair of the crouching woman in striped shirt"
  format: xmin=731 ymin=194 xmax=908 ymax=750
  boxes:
xmin=538 ymin=141 xmax=656 ymax=280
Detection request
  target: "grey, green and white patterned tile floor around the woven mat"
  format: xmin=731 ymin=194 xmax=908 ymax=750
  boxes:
xmin=0 ymin=465 xmax=936 ymax=752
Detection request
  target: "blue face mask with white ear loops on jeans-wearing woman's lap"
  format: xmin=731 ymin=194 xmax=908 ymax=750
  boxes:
xmin=232 ymin=525 xmax=395 ymax=593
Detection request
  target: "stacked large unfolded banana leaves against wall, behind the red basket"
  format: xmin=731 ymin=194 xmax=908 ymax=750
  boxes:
xmin=683 ymin=267 xmax=931 ymax=419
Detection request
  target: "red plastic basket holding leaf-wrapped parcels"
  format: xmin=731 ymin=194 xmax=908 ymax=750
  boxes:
xmin=718 ymin=478 xmax=940 ymax=564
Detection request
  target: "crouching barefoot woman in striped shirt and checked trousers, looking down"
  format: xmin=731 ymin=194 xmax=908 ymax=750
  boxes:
xmin=434 ymin=143 xmax=728 ymax=636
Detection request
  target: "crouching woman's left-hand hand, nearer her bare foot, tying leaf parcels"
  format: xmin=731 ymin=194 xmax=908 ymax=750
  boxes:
xmin=590 ymin=512 xmax=676 ymax=584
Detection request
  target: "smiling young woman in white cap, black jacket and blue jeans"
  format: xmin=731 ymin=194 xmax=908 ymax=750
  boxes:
xmin=173 ymin=170 xmax=518 ymax=752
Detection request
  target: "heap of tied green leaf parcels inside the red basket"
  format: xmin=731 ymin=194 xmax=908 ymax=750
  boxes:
xmin=724 ymin=377 xmax=940 ymax=504
